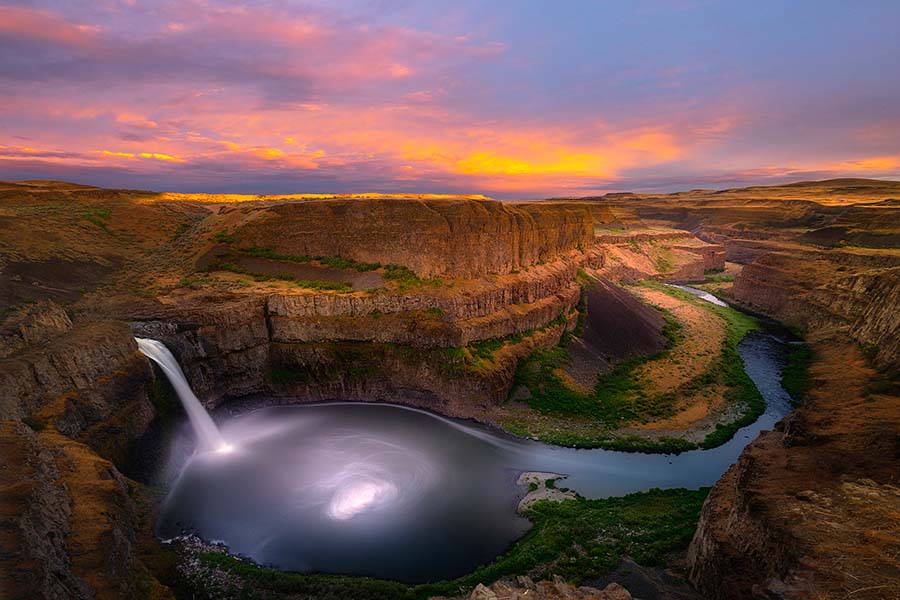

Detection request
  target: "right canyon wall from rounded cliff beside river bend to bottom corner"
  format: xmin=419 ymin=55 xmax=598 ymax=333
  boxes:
xmin=689 ymin=246 xmax=900 ymax=600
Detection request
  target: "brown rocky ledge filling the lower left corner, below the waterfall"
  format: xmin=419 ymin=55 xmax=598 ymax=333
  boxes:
xmin=0 ymin=421 xmax=149 ymax=600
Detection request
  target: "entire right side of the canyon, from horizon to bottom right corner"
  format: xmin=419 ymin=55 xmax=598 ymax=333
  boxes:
xmin=592 ymin=180 xmax=900 ymax=599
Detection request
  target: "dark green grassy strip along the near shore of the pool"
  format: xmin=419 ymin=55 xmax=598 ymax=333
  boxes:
xmin=172 ymin=488 xmax=709 ymax=600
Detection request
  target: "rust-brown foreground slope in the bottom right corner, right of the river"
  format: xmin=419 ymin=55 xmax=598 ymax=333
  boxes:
xmin=688 ymin=338 xmax=900 ymax=600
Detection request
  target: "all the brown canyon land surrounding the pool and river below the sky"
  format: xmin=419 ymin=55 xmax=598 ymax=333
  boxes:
xmin=0 ymin=179 xmax=900 ymax=600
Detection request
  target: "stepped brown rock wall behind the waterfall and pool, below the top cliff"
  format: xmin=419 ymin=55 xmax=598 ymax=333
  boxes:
xmin=125 ymin=249 xmax=604 ymax=406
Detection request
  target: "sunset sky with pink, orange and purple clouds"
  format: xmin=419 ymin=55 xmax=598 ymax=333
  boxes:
xmin=0 ymin=0 xmax=900 ymax=198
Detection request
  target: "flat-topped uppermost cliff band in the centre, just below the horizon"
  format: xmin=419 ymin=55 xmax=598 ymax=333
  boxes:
xmin=223 ymin=198 xmax=593 ymax=278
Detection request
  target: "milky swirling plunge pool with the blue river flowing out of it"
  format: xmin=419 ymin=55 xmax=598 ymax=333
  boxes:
xmin=158 ymin=334 xmax=790 ymax=581
